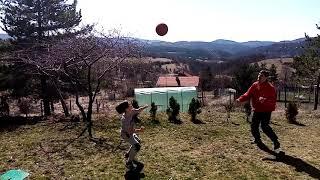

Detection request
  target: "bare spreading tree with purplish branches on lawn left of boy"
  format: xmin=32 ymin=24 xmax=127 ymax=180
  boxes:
xmin=42 ymin=31 xmax=139 ymax=138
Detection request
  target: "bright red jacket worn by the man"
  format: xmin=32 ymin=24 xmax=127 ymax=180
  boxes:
xmin=238 ymin=81 xmax=277 ymax=112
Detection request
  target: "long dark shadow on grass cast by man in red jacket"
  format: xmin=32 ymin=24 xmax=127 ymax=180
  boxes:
xmin=258 ymin=144 xmax=320 ymax=179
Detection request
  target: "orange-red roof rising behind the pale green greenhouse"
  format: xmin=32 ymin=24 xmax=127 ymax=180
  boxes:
xmin=157 ymin=76 xmax=199 ymax=87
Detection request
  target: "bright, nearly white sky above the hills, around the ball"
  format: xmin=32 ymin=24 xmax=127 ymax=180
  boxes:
xmin=1 ymin=0 xmax=320 ymax=42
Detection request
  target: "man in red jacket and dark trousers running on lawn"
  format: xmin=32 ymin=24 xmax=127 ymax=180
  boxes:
xmin=236 ymin=70 xmax=280 ymax=151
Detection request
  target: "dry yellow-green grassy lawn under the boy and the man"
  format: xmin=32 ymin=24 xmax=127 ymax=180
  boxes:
xmin=0 ymin=107 xmax=320 ymax=180
